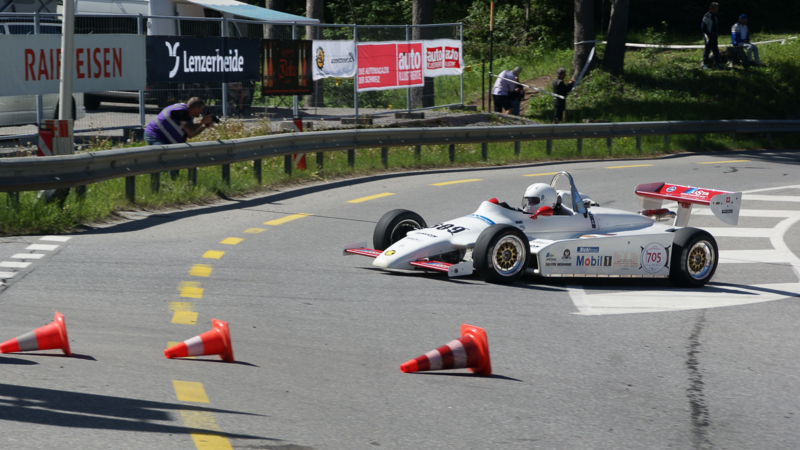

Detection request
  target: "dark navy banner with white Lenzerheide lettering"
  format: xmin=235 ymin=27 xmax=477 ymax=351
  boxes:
xmin=146 ymin=35 xmax=261 ymax=83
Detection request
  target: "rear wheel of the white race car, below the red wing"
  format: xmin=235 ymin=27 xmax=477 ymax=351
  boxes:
xmin=669 ymin=228 xmax=719 ymax=287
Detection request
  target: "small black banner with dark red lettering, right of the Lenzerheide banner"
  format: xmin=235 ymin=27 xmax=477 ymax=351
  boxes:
xmin=261 ymin=39 xmax=314 ymax=96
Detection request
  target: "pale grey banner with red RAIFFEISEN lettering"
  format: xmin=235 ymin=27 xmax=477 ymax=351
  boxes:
xmin=0 ymin=34 xmax=146 ymax=96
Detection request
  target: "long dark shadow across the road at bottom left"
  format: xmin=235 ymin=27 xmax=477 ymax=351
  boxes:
xmin=0 ymin=383 xmax=280 ymax=441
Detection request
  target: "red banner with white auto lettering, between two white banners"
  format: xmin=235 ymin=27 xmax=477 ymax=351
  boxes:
xmin=358 ymin=41 xmax=424 ymax=92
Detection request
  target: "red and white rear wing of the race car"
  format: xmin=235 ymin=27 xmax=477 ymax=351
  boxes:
xmin=634 ymin=183 xmax=742 ymax=227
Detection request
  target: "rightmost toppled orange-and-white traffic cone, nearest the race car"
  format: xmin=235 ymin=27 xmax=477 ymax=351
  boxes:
xmin=400 ymin=324 xmax=492 ymax=377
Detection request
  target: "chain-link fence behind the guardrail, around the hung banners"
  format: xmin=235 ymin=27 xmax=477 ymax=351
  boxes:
xmin=0 ymin=10 xmax=463 ymax=138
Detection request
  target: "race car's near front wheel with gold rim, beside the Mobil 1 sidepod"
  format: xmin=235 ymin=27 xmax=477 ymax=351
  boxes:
xmin=472 ymin=224 xmax=530 ymax=284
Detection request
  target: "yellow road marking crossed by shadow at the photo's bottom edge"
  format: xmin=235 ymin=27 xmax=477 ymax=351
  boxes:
xmin=172 ymin=380 xmax=233 ymax=450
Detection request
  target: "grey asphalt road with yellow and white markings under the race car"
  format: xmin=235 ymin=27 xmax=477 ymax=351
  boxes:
xmin=0 ymin=151 xmax=800 ymax=450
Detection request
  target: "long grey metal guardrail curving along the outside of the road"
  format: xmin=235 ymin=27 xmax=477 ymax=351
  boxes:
xmin=0 ymin=120 xmax=800 ymax=192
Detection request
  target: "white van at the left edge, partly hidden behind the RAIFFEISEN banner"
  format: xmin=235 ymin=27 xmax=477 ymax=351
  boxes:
xmin=0 ymin=22 xmax=86 ymax=126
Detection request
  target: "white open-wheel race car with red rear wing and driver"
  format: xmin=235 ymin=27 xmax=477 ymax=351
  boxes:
xmin=344 ymin=172 xmax=742 ymax=287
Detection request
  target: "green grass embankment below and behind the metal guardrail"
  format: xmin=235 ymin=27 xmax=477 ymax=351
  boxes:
xmin=0 ymin=35 xmax=800 ymax=235
